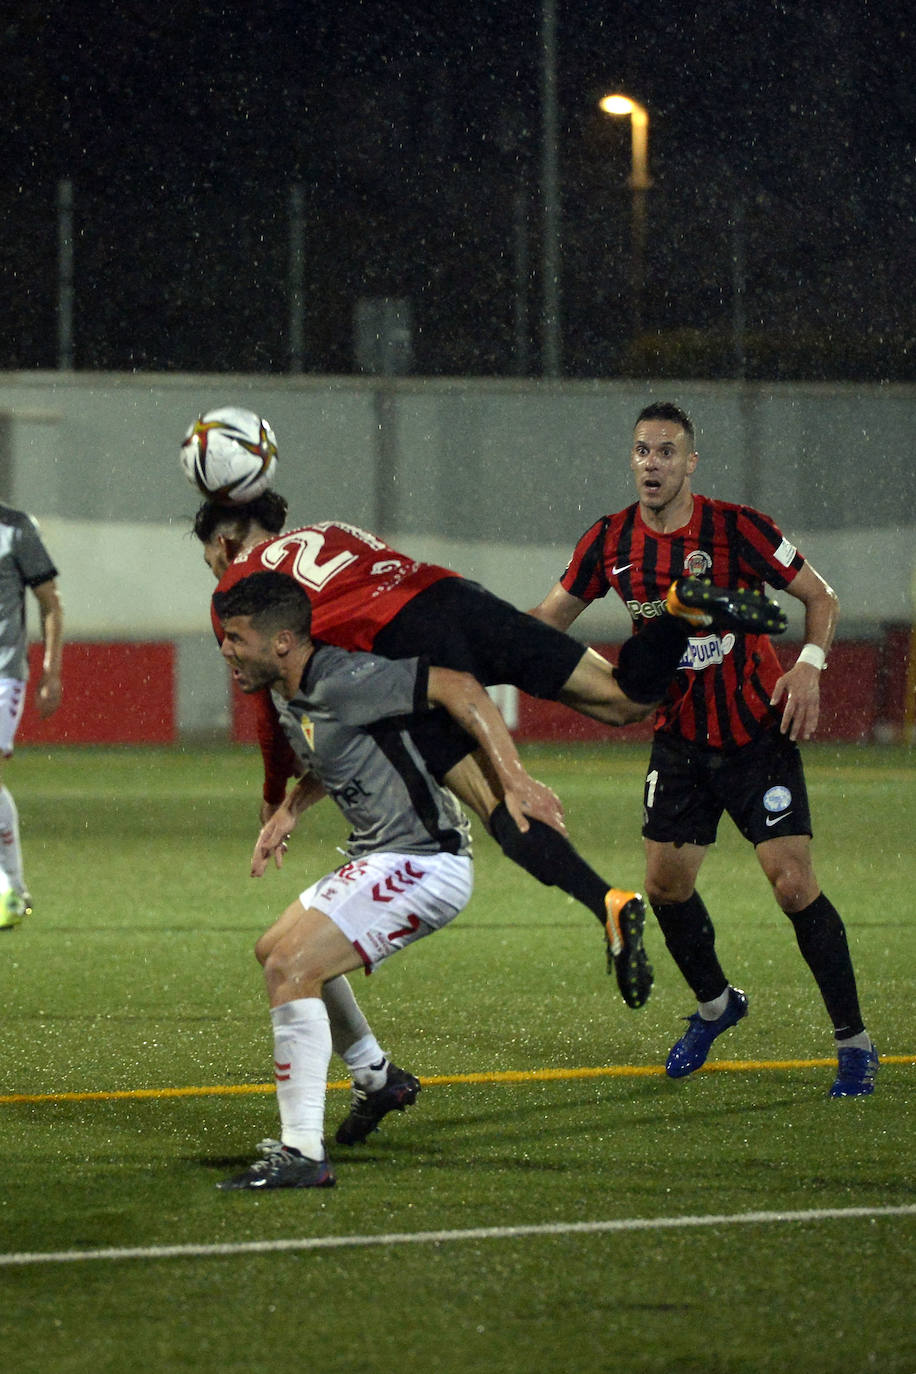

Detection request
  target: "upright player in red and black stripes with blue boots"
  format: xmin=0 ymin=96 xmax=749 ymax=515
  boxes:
xmin=533 ymin=403 xmax=878 ymax=1098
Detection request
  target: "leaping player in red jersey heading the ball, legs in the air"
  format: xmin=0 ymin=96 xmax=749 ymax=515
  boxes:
xmin=194 ymin=456 xmax=784 ymax=1007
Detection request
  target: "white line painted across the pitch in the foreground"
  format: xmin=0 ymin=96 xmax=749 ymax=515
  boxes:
xmin=0 ymin=1204 xmax=916 ymax=1268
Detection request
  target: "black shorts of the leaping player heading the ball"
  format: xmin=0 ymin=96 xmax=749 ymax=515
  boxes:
xmin=372 ymin=577 xmax=585 ymax=779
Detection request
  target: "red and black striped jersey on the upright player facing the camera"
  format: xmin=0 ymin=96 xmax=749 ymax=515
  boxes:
xmin=560 ymin=496 xmax=805 ymax=749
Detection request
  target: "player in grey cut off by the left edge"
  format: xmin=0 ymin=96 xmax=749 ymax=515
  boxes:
xmin=0 ymin=504 xmax=63 ymax=930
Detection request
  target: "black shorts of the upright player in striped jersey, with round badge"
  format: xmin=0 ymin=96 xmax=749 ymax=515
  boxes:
xmin=643 ymin=730 xmax=812 ymax=845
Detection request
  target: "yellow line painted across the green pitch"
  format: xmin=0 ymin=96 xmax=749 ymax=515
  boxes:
xmin=0 ymin=1054 xmax=916 ymax=1106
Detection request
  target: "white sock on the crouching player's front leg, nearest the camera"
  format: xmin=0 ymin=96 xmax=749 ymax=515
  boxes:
xmin=271 ymin=998 xmax=331 ymax=1160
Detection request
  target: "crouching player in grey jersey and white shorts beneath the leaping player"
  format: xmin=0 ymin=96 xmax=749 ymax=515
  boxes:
xmin=214 ymin=572 xmax=562 ymax=1189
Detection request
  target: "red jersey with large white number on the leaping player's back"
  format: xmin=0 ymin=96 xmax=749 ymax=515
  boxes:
xmin=210 ymin=521 xmax=459 ymax=804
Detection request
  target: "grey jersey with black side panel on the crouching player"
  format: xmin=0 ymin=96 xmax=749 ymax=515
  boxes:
xmin=272 ymin=644 xmax=471 ymax=859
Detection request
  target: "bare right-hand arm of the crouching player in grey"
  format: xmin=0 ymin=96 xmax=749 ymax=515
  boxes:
xmin=427 ymin=668 xmax=566 ymax=834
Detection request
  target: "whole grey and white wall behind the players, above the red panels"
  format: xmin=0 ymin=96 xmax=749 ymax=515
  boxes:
xmin=0 ymin=372 xmax=916 ymax=728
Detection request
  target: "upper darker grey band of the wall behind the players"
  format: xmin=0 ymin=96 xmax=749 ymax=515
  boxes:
xmin=0 ymin=372 xmax=916 ymax=547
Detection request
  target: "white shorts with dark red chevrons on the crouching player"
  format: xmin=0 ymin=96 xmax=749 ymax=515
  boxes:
xmin=299 ymin=853 xmax=474 ymax=973
